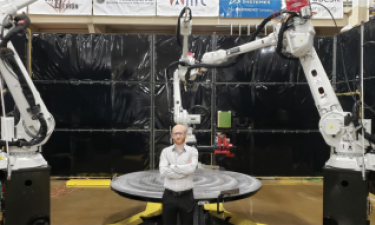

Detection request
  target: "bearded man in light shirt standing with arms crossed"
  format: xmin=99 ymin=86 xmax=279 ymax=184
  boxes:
xmin=159 ymin=125 xmax=198 ymax=225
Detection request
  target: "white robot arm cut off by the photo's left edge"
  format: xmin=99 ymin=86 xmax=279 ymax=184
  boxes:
xmin=0 ymin=0 xmax=55 ymax=176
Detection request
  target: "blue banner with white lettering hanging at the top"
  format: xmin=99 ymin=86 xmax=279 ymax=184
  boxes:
xmin=219 ymin=0 xmax=281 ymax=18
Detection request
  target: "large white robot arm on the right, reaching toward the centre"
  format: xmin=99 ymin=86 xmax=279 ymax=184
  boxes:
xmin=195 ymin=1 xmax=375 ymax=171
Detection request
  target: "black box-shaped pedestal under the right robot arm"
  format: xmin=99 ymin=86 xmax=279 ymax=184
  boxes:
xmin=323 ymin=166 xmax=371 ymax=225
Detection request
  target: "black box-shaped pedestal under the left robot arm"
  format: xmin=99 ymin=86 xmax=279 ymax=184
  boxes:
xmin=0 ymin=166 xmax=51 ymax=225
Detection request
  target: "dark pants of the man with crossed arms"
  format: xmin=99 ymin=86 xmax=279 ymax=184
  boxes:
xmin=163 ymin=189 xmax=195 ymax=225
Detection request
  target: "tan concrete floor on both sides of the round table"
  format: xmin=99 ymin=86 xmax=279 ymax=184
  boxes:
xmin=51 ymin=181 xmax=375 ymax=225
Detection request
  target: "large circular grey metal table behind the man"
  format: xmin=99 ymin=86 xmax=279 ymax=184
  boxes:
xmin=111 ymin=169 xmax=262 ymax=202
